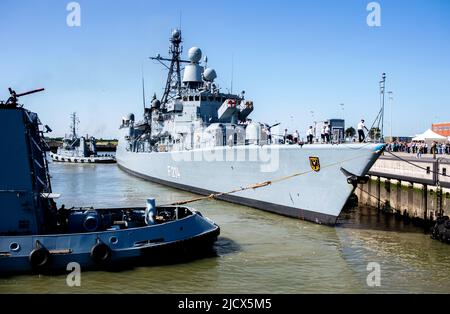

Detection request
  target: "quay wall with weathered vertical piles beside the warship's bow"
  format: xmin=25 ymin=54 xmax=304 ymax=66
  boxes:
xmin=355 ymin=156 xmax=450 ymax=222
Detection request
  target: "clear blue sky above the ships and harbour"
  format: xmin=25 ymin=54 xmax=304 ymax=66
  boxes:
xmin=0 ymin=0 xmax=450 ymax=138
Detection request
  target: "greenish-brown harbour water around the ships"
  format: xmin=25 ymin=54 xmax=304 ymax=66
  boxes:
xmin=0 ymin=163 xmax=450 ymax=293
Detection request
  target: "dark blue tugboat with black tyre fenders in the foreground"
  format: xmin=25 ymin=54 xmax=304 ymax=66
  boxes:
xmin=0 ymin=89 xmax=220 ymax=274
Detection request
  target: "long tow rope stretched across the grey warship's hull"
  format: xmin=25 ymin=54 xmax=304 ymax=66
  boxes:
xmin=163 ymin=154 xmax=374 ymax=206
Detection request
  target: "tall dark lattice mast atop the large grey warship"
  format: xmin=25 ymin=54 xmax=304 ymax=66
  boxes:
xmin=150 ymin=29 xmax=189 ymax=107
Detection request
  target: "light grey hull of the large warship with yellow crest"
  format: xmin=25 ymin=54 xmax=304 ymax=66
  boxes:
xmin=116 ymin=136 xmax=384 ymax=225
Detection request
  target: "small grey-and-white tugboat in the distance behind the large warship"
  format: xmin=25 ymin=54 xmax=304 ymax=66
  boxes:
xmin=50 ymin=113 xmax=116 ymax=164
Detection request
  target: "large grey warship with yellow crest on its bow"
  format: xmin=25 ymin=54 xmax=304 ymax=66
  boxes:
xmin=116 ymin=29 xmax=384 ymax=225
